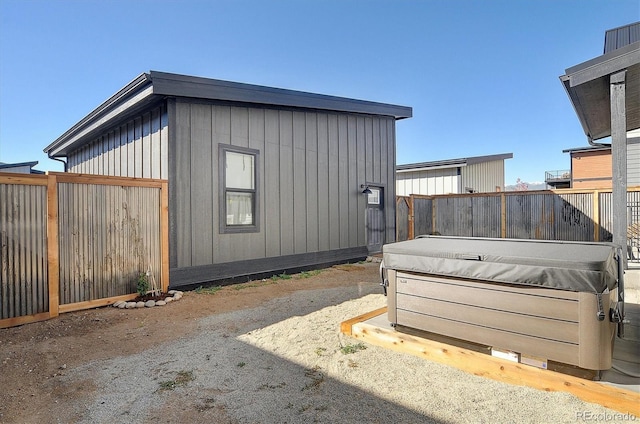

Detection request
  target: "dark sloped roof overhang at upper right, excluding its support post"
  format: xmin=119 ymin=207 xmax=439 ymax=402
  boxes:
xmin=560 ymin=42 xmax=640 ymax=140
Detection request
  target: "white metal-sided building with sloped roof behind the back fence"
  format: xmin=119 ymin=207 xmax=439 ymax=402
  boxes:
xmin=396 ymin=153 xmax=513 ymax=196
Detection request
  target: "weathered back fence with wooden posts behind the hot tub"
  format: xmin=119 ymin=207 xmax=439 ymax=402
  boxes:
xmin=396 ymin=187 xmax=640 ymax=261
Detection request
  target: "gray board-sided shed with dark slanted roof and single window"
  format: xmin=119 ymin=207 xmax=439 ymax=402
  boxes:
xmin=44 ymin=71 xmax=412 ymax=287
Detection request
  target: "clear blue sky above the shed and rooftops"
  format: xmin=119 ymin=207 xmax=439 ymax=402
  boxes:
xmin=0 ymin=0 xmax=640 ymax=184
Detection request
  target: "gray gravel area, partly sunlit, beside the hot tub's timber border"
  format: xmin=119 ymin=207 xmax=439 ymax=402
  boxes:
xmin=52 ymin=276 xmax=635 ymax=424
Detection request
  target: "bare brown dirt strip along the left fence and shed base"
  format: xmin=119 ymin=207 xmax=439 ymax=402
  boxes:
xmin=0 ymin=264 xmax=377 ymax=423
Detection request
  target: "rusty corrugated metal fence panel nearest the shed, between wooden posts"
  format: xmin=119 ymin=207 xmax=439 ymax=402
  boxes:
xmin=58 ymin=183 xmax=161 ymax=304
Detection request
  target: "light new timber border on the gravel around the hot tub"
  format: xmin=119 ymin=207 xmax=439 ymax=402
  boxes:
xmin=340 ymin=308 xmax=640 ymax=417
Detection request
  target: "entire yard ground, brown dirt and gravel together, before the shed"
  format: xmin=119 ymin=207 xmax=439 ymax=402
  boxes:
xmin=0 ymin=263 xmax=633 ymax=424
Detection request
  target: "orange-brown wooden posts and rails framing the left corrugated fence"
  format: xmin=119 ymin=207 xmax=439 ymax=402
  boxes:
xmin=0 ymin=172 xmax=169 ymax=328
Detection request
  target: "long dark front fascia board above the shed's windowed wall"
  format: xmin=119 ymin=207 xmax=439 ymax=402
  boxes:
xmin=149 ymin=71 xmax=413 ymax=119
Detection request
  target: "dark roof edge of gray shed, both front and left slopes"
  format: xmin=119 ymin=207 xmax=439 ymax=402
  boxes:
xmin=44 ymin=71 xmax=413 ymax=157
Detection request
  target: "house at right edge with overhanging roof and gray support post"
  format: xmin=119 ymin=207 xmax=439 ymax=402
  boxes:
xmin=560 ymin=22 xmax=640 ymax=266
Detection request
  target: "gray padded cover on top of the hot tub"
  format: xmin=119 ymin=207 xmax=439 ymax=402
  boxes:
xmin=382 ymin=236 xmax=618 ymax=293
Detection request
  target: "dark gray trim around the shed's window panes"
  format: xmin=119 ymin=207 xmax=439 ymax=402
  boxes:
xmin=218 ymin=144 xmax=260 ymax=234
